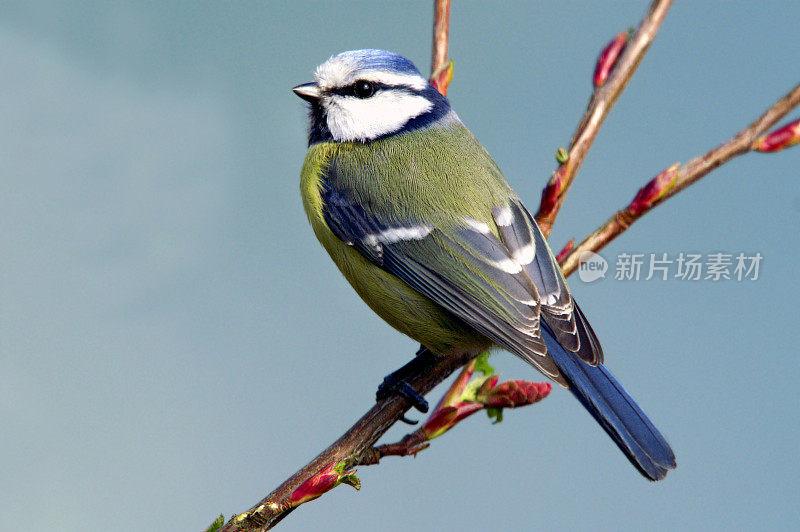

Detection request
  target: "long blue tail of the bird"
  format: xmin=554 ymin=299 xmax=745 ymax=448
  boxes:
xmin=542 ymin=324 xmax=676 ymax=480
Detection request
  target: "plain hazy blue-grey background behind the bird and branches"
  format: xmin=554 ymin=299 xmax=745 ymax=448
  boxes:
xmin=0 ymin=1 xmax=800 ymax=531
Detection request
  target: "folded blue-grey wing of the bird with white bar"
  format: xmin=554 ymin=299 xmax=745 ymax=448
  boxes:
xmin=321 ymin=177 xmax=599 ymax=384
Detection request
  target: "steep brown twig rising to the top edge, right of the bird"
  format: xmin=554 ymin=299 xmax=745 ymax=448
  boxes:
xmin=536 ymin=0 xmax=672 ymax=237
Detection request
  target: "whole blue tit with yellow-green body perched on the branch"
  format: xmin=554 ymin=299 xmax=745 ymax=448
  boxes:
xmin=292 ymin=49 xmax=676 ymax=480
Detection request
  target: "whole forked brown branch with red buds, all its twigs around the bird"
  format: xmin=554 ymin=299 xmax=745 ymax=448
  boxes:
xmin=214 ymin=0 xmax=800 ymax=531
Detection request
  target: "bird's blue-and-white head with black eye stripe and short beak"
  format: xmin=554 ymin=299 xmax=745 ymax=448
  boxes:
xmin=292 ymin=50 xmax=450 ymax=144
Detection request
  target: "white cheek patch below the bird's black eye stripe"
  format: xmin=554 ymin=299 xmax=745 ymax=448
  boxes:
xmin=325 ymin=89 xmax=433 ymax=142
